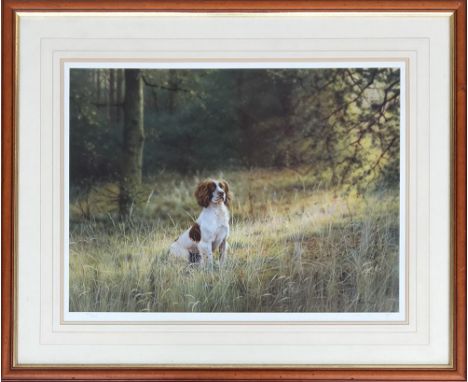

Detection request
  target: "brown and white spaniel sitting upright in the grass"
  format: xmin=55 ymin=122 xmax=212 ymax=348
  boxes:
xmin=169 ymin=179 xmax=232 ymax=264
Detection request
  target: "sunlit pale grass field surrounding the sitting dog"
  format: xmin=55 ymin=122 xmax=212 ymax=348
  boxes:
xmin=70 ymin=170 xmax=399 ymax=312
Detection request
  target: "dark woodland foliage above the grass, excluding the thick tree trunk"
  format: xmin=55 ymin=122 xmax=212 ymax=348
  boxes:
xmin=70 ymin=68 xmax=400 ymax=191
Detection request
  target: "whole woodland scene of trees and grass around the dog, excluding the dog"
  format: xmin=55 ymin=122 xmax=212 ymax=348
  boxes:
xmin=70 ymin=68 xmax=400 ymax=312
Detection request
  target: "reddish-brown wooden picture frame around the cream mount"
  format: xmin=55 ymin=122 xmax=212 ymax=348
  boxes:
xmin=1 ymin=0 xmax=466 ymax=381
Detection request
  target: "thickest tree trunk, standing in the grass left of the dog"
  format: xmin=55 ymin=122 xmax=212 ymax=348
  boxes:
xmin=119 ymin=69 xmax=145 ymax=218
